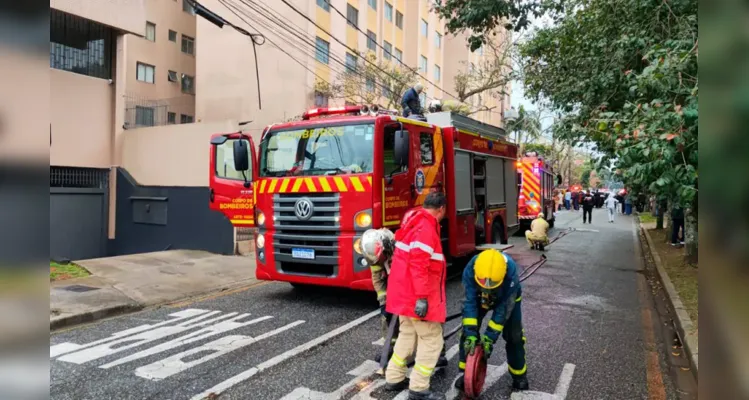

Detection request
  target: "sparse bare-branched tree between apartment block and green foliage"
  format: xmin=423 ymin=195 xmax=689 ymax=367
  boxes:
xmin=454 ymin=36 xmax=516 ymax=114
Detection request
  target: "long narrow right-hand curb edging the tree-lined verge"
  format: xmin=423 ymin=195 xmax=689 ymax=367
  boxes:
xmin=638 ymin=223 xmax=699 ymax=379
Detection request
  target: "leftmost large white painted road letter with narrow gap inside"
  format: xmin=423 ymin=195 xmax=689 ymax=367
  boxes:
xmin=58 ymin=311 xmax=238 ymax=364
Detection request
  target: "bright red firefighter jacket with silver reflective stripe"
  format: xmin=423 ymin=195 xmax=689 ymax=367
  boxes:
xmin=385 ymin=209 xmax=447 ymax=323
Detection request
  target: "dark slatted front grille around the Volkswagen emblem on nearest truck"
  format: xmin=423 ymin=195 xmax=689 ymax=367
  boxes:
xmin=273 ymin=193 xmax=340 ymax=276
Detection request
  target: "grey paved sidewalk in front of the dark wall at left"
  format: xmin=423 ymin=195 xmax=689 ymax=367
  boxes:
xmin=49 ymin=250 xmax=256 ymax=330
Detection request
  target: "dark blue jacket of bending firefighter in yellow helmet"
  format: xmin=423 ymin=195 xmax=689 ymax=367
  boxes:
xmin=463 ymin=253 xmax=522 ymax=342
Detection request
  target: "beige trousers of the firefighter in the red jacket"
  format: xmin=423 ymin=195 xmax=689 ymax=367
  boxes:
xmin=385 ymin=316 xmax=444 ymax=392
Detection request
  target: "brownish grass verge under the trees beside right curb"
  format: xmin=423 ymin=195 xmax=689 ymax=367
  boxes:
xmin=640 ymin=228 xmax=699 ymax=328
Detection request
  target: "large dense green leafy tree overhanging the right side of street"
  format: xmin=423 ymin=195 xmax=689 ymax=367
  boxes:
xmin=520 ymin=0 xmax=698 ymax=262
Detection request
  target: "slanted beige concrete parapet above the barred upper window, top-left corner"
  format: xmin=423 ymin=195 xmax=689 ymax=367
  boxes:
xmin=49 ymin=0 xmax=146 ymax=36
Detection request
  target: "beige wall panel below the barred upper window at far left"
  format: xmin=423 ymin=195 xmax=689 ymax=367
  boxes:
xmin=49 ymin=69 xmax=114 ymax=168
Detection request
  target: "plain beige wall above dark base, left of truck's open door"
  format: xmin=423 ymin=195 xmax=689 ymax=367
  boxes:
xmin=117 ymin=120 xmax=238 ymax=186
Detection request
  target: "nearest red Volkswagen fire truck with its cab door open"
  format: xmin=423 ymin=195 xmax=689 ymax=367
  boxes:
xmin=210 ymin=106 xmax=518 ymax=290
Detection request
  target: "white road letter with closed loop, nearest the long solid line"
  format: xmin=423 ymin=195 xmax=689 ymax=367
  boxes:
xmin=135 ymin=321 xmax=304 ymax=381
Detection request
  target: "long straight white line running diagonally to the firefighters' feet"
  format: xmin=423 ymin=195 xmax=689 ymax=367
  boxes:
xmin=192 ymin=310 xmax=380 ymax=400
